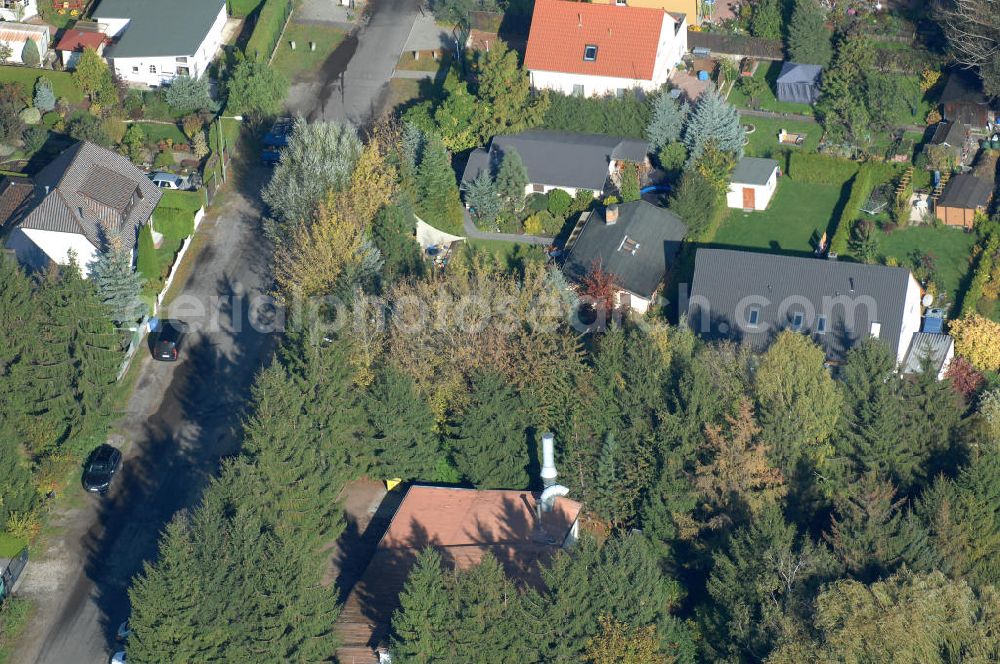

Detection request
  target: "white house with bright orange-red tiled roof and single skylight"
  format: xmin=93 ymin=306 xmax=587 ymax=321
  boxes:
xmin=524 ymin=0 xmax=687 ymax=97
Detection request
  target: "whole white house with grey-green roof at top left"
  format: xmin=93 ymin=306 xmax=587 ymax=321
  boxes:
xmin=94 ymin=0 xmax=226 ymax=87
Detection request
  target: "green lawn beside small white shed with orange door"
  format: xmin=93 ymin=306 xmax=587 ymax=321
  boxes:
xmin=714 ymin=177 xmax=842 ymax=253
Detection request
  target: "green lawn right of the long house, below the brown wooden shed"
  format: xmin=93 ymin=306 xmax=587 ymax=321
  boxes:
xmin=881 ymin=226 xmax=976 ymax=302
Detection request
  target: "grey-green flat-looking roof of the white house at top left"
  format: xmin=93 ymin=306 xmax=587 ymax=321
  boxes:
xmin=93 ymin=0 xmax=225 ymax=58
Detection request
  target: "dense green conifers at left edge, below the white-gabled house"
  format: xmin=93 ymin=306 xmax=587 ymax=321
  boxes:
xmin=0 ymin=258 xmax=122 ymax=530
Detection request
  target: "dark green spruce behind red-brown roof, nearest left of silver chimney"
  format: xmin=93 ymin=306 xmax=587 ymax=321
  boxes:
xmin=449 ymin=372 xmax=528 ymax=489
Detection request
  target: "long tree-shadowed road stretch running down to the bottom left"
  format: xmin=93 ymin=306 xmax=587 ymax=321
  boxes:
xmin=18 ymin=163 xmax=274 ymax=664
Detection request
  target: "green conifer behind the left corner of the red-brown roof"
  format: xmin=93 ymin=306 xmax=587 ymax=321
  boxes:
xmin=364 ymin=368 xmax=441 ymax=480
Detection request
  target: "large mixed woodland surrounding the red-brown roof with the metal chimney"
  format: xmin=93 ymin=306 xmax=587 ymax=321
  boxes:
xmin=129 ymin=109 xmax=1000 ymax=664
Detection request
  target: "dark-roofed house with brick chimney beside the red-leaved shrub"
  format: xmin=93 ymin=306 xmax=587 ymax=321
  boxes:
xmin=563 ymin=201 xmax=687 ymax=300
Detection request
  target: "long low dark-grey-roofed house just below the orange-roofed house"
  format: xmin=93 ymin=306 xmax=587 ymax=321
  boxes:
xmin=462 ymin=129 xmax=649 ymax=191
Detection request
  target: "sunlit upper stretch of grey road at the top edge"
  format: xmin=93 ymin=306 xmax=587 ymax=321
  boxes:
xmin=288 ymin=0 xmax=420 ymax=127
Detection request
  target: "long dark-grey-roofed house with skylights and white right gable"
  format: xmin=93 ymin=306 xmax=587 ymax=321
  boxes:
xmin=687 ymin=249 xmax=920 ymax=361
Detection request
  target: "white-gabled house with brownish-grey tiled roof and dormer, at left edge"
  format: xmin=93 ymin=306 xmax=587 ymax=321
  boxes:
xmin=6 ymin=143 xmax=161 ymax=276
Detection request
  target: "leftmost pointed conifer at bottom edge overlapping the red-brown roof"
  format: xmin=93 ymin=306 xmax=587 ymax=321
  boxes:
xmin=392 ymin=547 xmax=455 ymax=664
